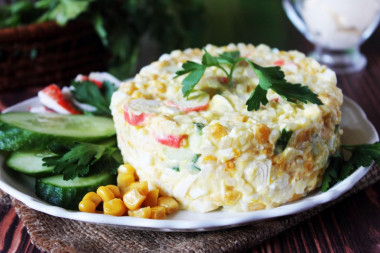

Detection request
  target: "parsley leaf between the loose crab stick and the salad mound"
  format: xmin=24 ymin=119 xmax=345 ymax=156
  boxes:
xmin=71 ymin=81 xmax=115 ymax=116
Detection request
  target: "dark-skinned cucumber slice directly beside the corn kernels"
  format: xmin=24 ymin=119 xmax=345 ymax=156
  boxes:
xmin=35 ymin=172 xmax=116 ymax=210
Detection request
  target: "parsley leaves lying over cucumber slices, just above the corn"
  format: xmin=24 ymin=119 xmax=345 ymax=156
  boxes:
xmin=43 ymin=143 xmax=123 ymax=180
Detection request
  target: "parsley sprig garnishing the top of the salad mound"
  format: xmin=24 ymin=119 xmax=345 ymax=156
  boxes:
xmin=175 ymin=49 xmax=322 ymax=111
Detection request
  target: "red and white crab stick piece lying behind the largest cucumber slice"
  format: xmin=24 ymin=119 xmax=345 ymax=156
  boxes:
xmin=38 ymin=84 xmax=81 ymax=114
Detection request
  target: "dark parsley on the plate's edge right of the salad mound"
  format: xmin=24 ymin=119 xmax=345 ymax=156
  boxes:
xmin=322 ymin=142 xmax=380 ymax=192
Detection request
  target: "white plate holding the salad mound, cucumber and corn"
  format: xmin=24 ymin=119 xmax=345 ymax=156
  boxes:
xmin=0 ymin=97 xmax=379 ymax=232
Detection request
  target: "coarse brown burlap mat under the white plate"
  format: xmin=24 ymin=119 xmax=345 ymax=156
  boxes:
xmin=0 ymin=165 xmax=380 ymax=253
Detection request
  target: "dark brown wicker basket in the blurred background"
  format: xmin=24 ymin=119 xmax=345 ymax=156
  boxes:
xmin=0 ymin=21 xmax=109 ymax=91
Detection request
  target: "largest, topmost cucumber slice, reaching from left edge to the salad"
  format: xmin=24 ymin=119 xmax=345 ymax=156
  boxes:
xmin=0 ymin=112 xmax=115 ymax=151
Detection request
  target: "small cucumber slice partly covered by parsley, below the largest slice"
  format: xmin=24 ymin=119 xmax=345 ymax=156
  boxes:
xmin=6 ymin=151 xmax=54 ymax=177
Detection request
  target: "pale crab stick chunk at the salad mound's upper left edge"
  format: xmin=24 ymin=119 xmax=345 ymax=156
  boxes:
xmin=124 ymin=99 xmax=160 ymax=126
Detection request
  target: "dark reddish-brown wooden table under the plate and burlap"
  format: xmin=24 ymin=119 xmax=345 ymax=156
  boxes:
xmin=0 ymin=31 xmax=380 ymax=252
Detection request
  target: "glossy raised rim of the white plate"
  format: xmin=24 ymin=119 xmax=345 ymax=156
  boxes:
xmin=0 ymin=96 xmax=379 ymax=232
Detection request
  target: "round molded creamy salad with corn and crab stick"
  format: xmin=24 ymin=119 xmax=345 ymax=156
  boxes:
xmin=111 ymin=44 xmax=343 ymax=212
